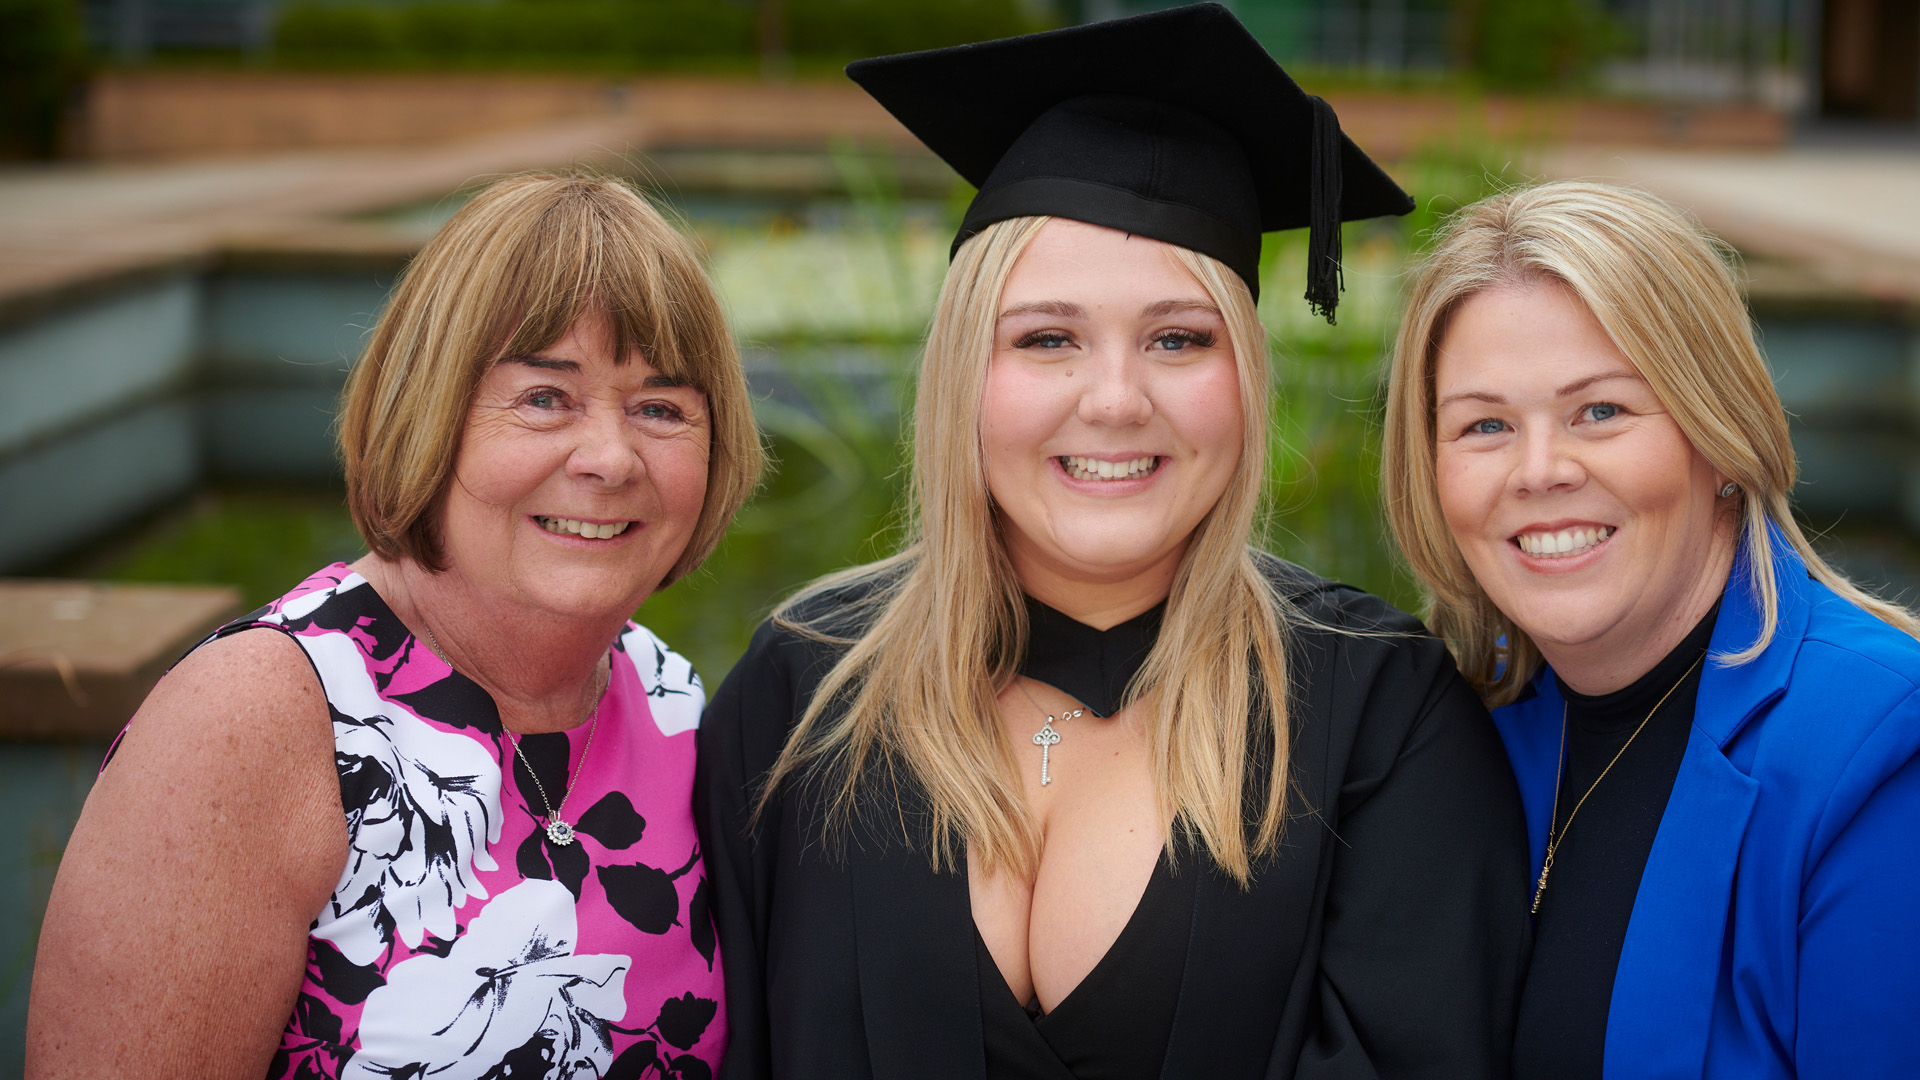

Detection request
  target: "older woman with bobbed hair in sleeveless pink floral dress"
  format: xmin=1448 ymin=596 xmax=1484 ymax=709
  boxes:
xmin=27 ymin=177 xmax=760 ymax=1078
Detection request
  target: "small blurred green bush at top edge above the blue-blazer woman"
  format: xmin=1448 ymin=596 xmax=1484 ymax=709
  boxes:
xmin=1455 ymin=0 xmax=1622 ymax=90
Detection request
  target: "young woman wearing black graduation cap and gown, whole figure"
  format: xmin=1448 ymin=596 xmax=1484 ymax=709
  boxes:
xmin=695 ymin=6 xmax=1526 ymax=1080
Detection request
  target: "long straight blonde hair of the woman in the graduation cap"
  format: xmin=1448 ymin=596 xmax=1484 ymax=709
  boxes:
xmin=760 ymin=217 xmax=1288 ymax=884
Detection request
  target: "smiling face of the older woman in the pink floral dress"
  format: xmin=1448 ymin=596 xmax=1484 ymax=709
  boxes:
xmin=440 ymin=317 xmax=710 ymax=615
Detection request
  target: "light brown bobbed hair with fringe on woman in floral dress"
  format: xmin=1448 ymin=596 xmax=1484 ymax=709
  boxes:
xmin=338 ymin=173 xmax=762 ymax=586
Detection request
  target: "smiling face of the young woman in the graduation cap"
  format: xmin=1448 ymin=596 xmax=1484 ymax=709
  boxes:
xmin=979 ymin=219 xmax=1242 ymax=613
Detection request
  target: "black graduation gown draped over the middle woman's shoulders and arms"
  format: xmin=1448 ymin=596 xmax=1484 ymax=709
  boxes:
xmin=695 ymin=559 xmax=1528 ymax=1080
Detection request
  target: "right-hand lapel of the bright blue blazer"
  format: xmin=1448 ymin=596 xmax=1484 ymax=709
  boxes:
xmin=1605 ymin=530 xmax=1811 ymax=1078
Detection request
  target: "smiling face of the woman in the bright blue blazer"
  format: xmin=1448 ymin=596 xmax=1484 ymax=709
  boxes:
xmin=1434 ymin=282 xmax=1734 ymax=694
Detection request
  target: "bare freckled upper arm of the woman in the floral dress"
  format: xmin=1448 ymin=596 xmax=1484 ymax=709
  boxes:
xmin=27 ymin=628 xmax=348 ymax=1080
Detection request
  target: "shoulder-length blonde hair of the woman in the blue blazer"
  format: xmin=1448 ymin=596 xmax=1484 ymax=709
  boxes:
xmin=1380 ymin=181 xmax=1920 ymax=705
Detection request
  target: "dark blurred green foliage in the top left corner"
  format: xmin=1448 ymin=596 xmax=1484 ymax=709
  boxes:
xmin=0 ymin=0 xmax=86 ymax=158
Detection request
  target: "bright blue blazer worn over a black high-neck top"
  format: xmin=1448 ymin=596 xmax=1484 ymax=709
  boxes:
xmin=1494 ymin=532 xmax=1920 ymax=1080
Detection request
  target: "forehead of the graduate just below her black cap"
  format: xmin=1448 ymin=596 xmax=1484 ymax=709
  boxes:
xmin=1000 ymin=217 xmax=1208 ymax=309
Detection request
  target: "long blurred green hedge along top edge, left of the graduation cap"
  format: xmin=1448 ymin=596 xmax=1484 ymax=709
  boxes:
xmin=270 ymin=0 xmax=1044 ymax=71
